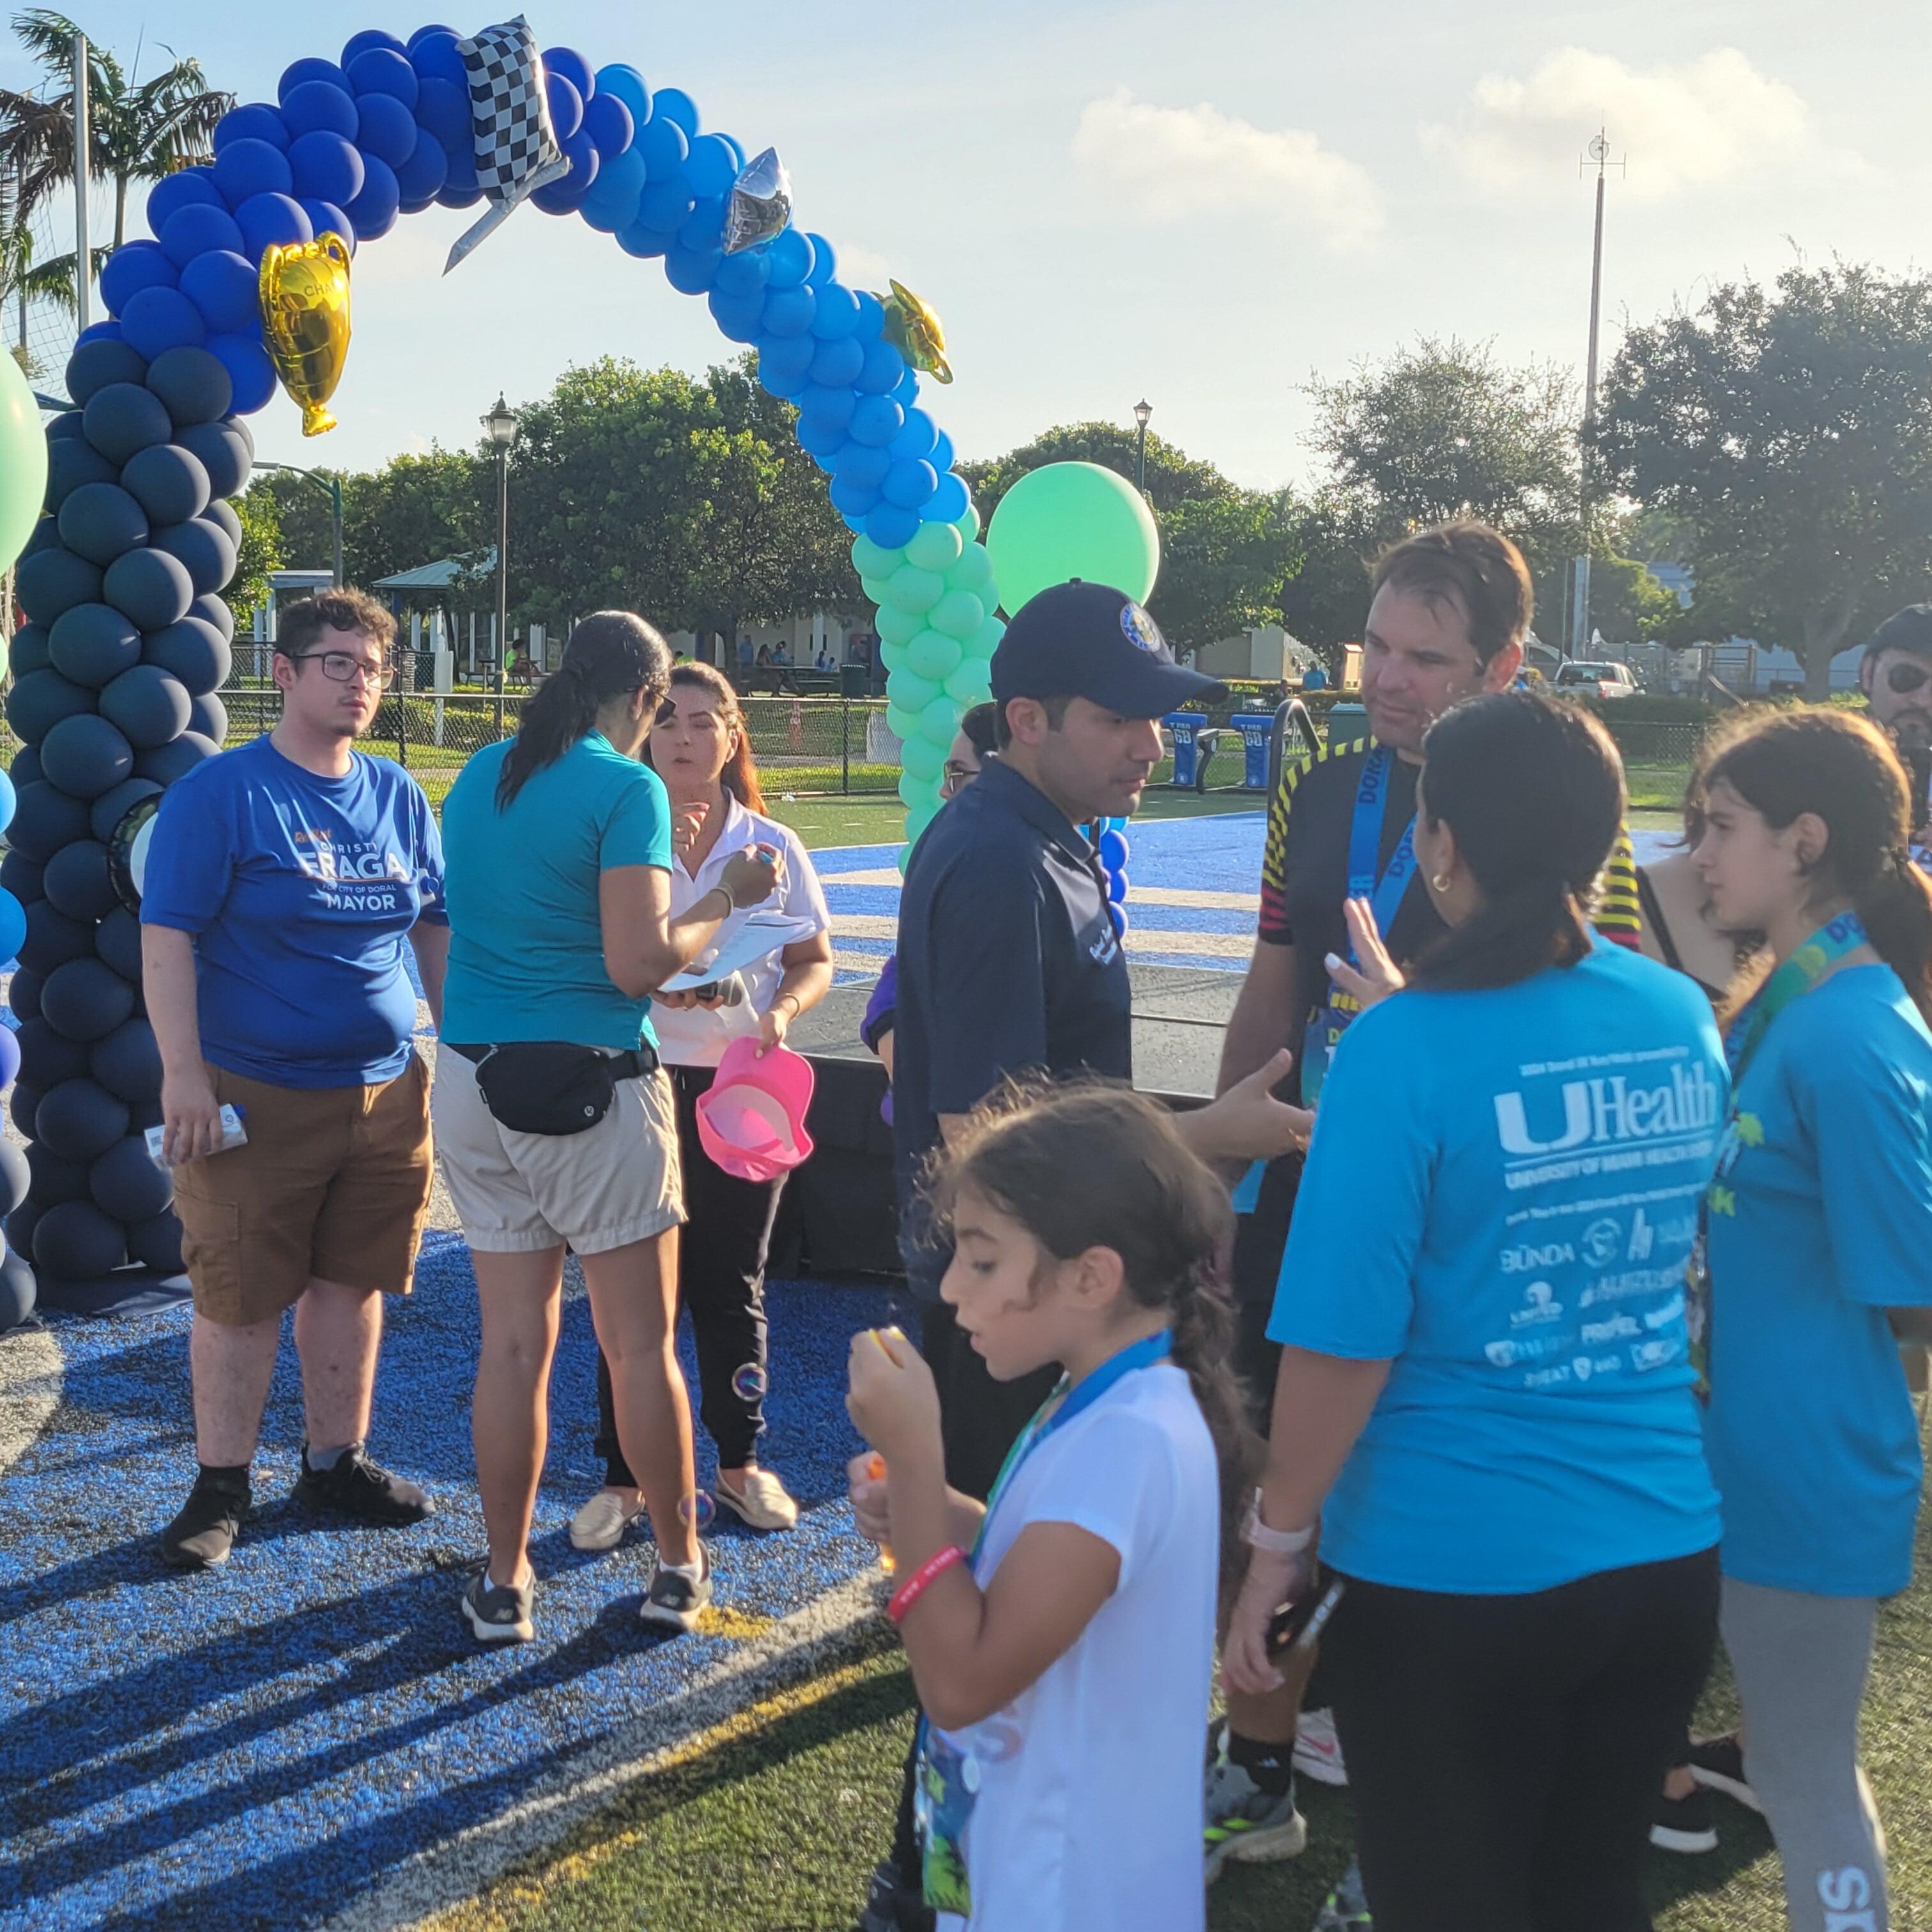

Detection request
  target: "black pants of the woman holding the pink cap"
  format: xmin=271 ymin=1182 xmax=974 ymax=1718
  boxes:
xmin=597 ymin=1066 xmax=785 ymax=1490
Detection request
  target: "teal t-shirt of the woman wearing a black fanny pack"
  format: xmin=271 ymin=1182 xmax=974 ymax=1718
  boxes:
xmin=442 ymin=732 xmax=670 ymax=1053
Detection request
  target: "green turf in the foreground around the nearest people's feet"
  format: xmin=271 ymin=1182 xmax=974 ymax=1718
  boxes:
xmin=431 ymin=1517 xmax=1932 ymax=1932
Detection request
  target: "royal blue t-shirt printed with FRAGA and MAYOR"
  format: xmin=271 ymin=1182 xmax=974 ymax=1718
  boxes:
xmin=141 ymin=736 xmax=442 ymax=1088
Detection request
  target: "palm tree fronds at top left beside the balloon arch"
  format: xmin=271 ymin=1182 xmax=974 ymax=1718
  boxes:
xmin=0 ymin=8 xmax=236 ymax=266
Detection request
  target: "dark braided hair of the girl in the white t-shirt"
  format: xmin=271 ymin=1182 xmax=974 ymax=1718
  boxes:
xmin=923 ymin=1078 xmax=1262 ymax=1588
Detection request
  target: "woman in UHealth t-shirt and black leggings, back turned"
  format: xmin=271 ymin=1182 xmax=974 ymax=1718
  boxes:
xmin=1223 ymin=692 xmax=1725 ymax=1932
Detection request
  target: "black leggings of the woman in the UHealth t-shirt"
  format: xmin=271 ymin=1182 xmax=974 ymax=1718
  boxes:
xmin=1323 ymin=1549 xmax=1717 ymax=1932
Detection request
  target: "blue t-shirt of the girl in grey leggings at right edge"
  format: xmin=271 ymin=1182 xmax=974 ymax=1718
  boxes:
xmin=1706 ymin=964 xmax=1932 ymax=1596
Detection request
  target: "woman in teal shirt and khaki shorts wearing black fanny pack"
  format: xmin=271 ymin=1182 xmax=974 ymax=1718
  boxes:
xmin=434 ymin=611 xmax=779 ymax=1644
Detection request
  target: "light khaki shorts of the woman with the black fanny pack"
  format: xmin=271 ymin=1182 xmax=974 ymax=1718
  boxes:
xmin=433 ymin=1051 xmax=684 ymax=1254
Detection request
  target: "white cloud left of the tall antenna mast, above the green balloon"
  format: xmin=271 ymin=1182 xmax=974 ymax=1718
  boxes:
xmin=1070 ymin=87 xmax=1381 ymax=247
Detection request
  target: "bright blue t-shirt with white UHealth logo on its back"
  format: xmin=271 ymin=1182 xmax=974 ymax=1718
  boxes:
xmin=1268 ymin=939 xmax=1727 ymax=1596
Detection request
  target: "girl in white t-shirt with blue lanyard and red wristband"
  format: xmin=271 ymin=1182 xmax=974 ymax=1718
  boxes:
xmin=847 ymin=1084 xmax=1254 ymax=1932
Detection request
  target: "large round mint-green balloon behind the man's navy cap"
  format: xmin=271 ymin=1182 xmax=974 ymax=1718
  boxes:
xmin=985 ymin=464 xmax=1161 ymax=617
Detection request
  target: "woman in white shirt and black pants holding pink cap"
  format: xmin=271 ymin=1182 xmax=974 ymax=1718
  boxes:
xmin=570 ymin=664 xmax=832 ymax=1549
